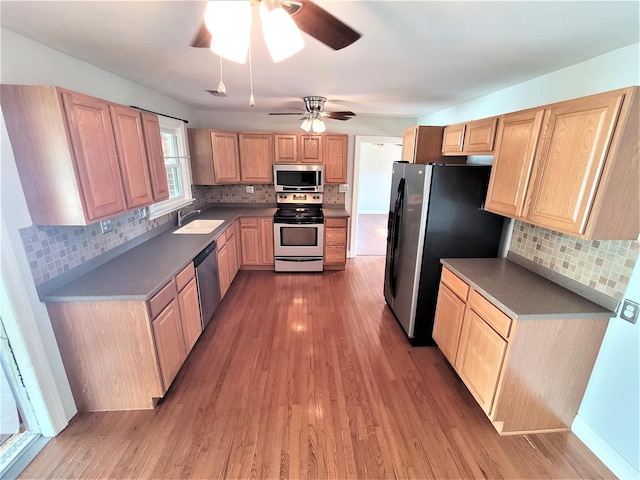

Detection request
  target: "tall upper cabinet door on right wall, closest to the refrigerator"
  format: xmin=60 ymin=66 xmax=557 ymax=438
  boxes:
xmin=485 ymin=109 xmax=544 ymax=218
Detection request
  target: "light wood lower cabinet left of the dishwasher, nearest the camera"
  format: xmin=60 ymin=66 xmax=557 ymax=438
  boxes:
xmin=47 ymin=264 xmax=202 ymax=412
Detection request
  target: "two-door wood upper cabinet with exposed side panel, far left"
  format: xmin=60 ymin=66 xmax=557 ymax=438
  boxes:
xmin=0 ymin=85 xmax=164 ymax=225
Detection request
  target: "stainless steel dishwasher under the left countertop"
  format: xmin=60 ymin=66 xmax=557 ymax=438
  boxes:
xmin=193 ymin=240 xmax=221 ymax=330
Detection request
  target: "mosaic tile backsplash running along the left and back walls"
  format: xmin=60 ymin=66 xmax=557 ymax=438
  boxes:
xmin=20 ymin=185 xmax=345 ymax=286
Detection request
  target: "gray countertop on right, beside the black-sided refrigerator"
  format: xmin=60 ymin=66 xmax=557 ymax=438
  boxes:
xmin=441 ymin=258 xmax=615 ymax=320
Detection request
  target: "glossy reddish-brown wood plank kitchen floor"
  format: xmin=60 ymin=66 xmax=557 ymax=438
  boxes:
xmin=21 ymin=256 xmax=613 ymax=479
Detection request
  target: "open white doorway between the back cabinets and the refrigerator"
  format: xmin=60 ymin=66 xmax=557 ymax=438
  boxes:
xmin=349 ymin=136 xmax=402 ymax=257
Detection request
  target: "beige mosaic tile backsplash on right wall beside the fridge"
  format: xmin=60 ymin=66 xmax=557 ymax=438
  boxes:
xmin=509 ymin=221 xmax=640 ymax=300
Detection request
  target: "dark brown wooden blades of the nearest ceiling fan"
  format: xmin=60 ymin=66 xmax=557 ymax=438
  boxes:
xmin=191 ymin=0 xmax=361 ymax=50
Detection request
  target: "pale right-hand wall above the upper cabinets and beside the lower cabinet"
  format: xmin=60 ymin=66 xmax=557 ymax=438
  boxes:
xmin=418 ymin=44 xmax=640 ymax=478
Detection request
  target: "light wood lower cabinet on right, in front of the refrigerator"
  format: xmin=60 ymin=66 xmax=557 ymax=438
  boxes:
xmin=433 ymin=268 xmax=607 ymax=435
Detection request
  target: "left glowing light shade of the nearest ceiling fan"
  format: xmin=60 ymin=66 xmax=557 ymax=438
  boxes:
xmin=204 ymin=1 xmax=251 ymax=63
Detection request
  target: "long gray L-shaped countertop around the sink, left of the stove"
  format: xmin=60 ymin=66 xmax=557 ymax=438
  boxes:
xmin=42 ymin=207 xmax=276 ymax=302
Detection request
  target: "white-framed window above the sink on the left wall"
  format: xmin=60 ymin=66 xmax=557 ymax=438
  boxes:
xmin=149 ymin=115 xmax=194 ymax=219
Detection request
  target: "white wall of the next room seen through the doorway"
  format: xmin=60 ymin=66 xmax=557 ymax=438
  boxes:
xmin=358 ymin=143 xmax=402 ymax=214
